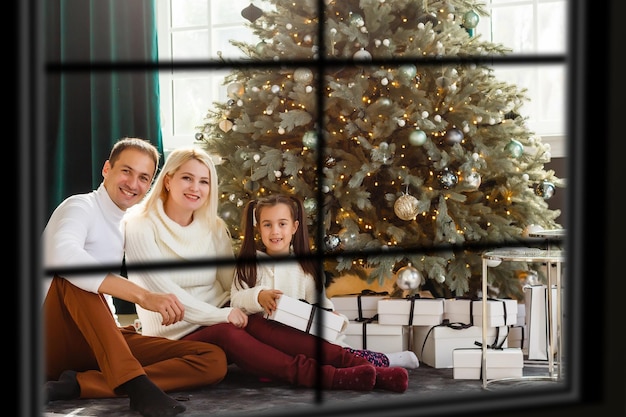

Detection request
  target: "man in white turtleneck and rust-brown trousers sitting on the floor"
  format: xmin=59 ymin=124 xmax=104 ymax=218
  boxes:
xmin=43 ymin=138 xmax=227 ymax=417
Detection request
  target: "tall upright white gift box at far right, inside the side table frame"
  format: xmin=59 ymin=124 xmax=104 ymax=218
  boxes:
xmin=524 ymin=285 xmax=557 ymax=360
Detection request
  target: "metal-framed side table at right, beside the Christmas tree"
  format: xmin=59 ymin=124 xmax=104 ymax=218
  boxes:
xmin=481 ymin=248 xmax=565 ymax=388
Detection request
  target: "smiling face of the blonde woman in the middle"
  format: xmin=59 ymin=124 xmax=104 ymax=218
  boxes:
xmin=164 ymin=159 xmax=211 ymax=224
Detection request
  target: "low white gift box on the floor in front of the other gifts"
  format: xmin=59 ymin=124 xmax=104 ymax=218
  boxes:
xmin=452 ymin=348 xmax=524 ymax=379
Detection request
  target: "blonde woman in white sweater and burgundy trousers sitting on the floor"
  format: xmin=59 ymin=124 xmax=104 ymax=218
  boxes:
xmin=124 ymin=147 xmax=408 ymax=392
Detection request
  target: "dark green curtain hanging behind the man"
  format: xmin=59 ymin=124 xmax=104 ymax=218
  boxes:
xmin=45 ymin=0 xmax=163 ymax=216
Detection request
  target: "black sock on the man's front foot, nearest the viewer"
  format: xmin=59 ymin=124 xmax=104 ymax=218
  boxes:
xmin=119 ymin=375 xmax=186 ymax=417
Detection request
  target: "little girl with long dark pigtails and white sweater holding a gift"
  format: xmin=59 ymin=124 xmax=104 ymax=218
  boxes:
xmin=231 ymin=194 xmax=419 ymax=378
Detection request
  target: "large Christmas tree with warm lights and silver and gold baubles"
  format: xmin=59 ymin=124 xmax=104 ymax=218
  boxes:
xmin=196 ymin=0 xmax=564 ymax=298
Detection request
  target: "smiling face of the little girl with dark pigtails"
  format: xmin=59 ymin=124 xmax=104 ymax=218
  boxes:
xmin=258 ymin=203 xmax=299 ymax=256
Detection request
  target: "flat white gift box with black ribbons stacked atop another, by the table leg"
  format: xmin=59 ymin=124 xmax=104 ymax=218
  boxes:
xmin=443 ymin=298 xmax=519 ymax=327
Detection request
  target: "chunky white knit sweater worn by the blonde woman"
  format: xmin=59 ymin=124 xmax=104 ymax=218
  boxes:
xmin=124 ymin=200 xmax=234 ymax=339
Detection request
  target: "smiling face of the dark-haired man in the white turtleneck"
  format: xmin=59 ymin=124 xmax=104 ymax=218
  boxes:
xmin=102 ymin=148 xmax=156 ymax=210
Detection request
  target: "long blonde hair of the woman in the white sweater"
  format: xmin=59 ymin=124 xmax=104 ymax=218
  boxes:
xmin=138 ymin=146 xmax=222 ymax=230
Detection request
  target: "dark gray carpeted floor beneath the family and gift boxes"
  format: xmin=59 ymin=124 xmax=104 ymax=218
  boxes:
xmin=43 ymin=364 xmax=566 ymax=417
